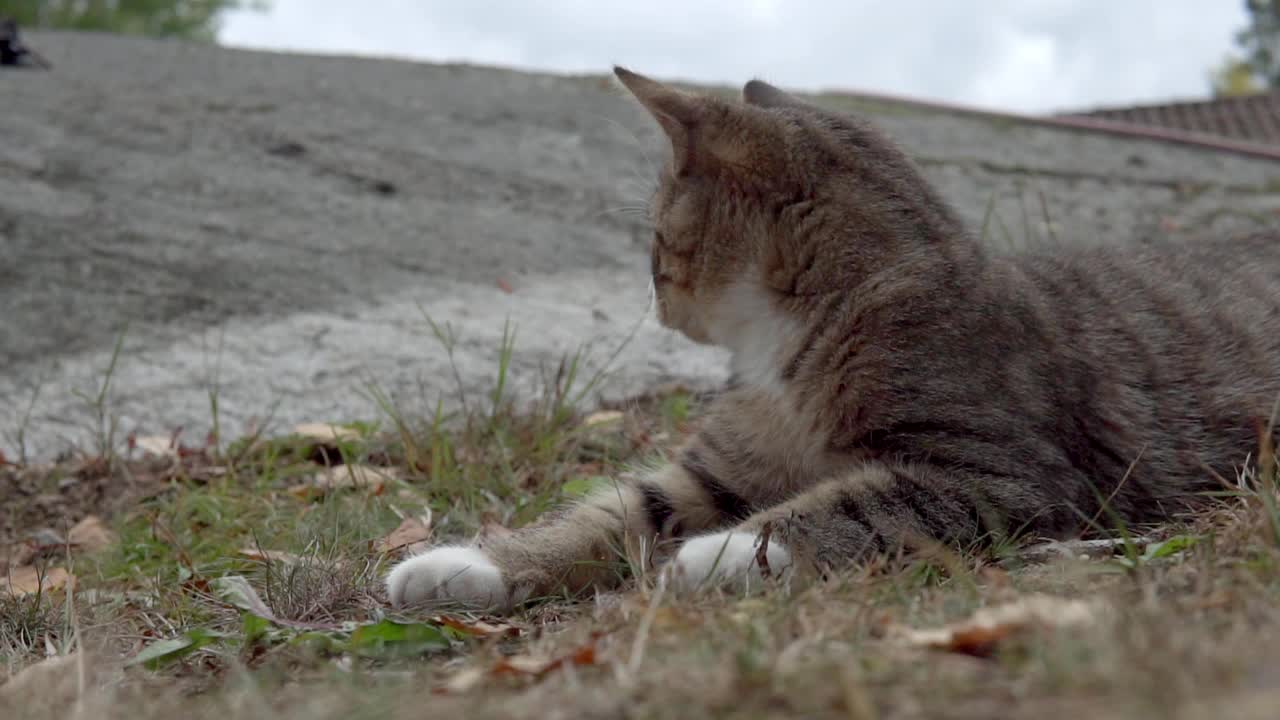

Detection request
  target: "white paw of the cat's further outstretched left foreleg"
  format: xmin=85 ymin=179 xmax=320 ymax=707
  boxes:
xmin=387 ymin=546 xmax=508 ymax=611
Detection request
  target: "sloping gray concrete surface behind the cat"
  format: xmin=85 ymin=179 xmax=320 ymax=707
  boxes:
xmin=0 ymin=33 xmax=1280 ymax=455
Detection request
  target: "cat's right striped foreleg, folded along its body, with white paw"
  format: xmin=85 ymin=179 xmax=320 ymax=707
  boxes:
xmin=666 ymin=462 xmax=1054 ymax=592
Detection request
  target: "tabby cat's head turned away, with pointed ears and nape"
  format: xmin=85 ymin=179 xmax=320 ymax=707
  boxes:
xmin=614 ymin=68 xmax=957 ymax=348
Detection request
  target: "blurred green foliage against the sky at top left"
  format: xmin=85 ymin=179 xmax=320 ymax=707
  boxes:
xmin=0 ymin=0 xmax=268 ymax=41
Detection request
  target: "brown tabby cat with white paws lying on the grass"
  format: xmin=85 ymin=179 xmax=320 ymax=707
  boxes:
xmin=387 ymin=68 xmax=1280 ymax=611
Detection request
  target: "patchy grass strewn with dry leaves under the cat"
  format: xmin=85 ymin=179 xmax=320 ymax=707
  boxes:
xmin=0 ymin=345 xmax=1280 ymax=720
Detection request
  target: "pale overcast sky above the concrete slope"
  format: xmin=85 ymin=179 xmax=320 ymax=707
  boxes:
xmin=221 ymin=0 xmax=1245 ymax=113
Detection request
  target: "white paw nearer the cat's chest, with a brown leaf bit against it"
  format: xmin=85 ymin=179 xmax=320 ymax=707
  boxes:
xmin=671 ymin=532 xmax=792 ymax=593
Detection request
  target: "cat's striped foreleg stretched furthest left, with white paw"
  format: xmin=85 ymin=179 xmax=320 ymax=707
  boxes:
xmin=387 ymin=430 xmax=767 ymax=611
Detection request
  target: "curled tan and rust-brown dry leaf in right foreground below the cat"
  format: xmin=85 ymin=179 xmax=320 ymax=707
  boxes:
xmin=888 ymin=594 xmax=1101 ymax=657
